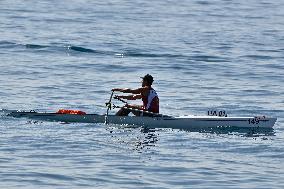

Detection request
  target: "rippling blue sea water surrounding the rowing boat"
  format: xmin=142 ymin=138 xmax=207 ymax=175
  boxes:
xmin=0 ymin=0 xmax=284 ymax=189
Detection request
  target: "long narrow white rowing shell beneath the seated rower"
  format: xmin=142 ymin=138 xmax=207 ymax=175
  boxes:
xmin=8 ymin=111 xmax=276 ymax=129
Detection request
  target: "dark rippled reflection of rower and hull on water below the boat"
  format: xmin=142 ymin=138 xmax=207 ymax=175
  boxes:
xmin=107 ymin=125 xmax=275 ymax=153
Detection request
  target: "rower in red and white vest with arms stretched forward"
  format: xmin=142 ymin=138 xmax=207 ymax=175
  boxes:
xmin=112 ymin=74 xmax=159 ymax=116
